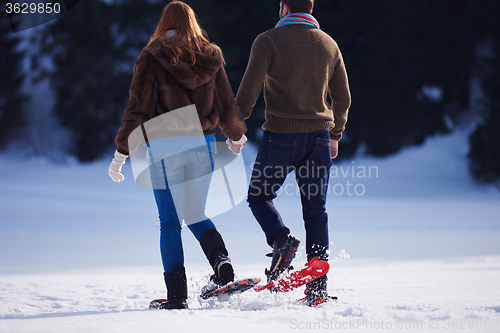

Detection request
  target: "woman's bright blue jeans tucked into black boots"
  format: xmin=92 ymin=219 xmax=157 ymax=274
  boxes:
xmin=149 ymin=151 xmax=216 ymax=273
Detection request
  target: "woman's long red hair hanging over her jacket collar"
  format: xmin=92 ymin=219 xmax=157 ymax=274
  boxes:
xmin=149 ymin=1 xmax=224 ymax=66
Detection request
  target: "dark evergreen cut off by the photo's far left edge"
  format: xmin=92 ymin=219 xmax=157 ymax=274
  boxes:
xmin=0 ymin=14 xmax=28 ymax=147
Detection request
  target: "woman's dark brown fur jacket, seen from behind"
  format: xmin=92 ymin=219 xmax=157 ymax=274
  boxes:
xmin=115 ymin=37 xmax=246 ymax=155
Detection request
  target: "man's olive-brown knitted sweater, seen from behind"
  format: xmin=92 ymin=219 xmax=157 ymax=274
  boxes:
xmin=236 ymin=25 xmax=351 ymax=141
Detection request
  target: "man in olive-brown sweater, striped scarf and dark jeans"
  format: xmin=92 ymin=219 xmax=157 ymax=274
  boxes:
xmin=236 ymin=0 xmax=351 ymax=305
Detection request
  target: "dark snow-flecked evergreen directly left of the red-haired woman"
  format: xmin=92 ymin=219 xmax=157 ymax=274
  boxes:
xmin=34 ymin=0 xmax=132 ymax=161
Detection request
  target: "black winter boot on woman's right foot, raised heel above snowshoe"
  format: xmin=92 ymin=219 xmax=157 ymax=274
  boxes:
xmin=200 ymin=229 xmax=234 ymax=285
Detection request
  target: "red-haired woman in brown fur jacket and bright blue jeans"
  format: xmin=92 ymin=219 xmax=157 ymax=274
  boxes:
xmin=109 ymin=1 xmax=246 ymax=309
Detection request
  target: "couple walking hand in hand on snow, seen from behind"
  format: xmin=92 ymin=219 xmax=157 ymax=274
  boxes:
xmin=109 ymin=0 xmax=350 ymax=309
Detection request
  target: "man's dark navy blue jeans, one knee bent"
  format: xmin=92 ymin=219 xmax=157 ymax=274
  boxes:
xmin=248 ymin=131 xmax=332 ymax=260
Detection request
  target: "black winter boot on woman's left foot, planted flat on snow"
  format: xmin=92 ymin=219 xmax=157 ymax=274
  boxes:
xmin=160 ymin=266 xmax=188 ymax=309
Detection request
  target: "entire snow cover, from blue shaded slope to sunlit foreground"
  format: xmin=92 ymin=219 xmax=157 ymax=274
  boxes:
xmin=0 ymin=130 xmax=500 ymax=333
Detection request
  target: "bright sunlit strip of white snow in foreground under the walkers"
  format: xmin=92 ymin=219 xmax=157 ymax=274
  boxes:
xmin=0 ymin=256 xmax=500 ymax=332
